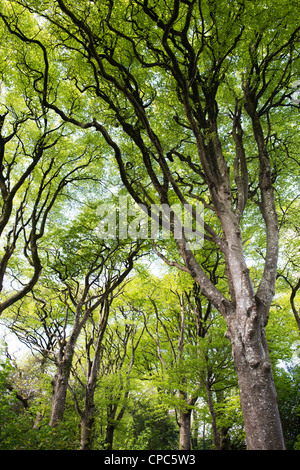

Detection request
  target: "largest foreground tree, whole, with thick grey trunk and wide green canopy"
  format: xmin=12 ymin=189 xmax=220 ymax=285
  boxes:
xmin=1 ymin=0 xmax=300 ymax=450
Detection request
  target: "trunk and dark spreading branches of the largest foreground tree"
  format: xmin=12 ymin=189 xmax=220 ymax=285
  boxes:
xmin=10 ymin=0 xmax=292 ymax=449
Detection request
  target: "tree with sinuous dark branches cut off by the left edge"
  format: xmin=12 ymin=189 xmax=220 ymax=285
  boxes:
xmin=0 ymin=10 xmax=100 ymax=313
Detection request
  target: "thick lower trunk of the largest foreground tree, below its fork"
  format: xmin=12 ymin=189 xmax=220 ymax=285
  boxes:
xmin=229 ymin=302 xmax=285 ymax=450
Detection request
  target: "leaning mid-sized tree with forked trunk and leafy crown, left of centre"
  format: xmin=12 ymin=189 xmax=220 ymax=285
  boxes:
xmin=1 ymin=207 xmax=144 ymax=426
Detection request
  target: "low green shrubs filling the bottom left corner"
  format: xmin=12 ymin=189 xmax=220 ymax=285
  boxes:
xmin=0 ymin=352 xmax=78 ymax=450
